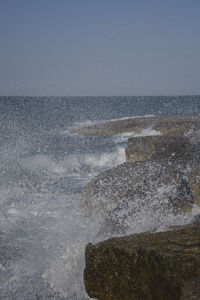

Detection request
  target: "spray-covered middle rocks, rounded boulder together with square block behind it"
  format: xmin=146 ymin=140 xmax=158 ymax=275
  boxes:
xmin=82 ymin=128 xmax=200 ymax=233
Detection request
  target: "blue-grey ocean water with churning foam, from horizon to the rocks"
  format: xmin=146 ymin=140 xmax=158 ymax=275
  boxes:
xmin=0 ymin=96 xmax=200 ymax=300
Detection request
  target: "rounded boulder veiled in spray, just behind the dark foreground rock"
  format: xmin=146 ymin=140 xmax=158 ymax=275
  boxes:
xmin=82 ymin=160 xmax=194 ymax=233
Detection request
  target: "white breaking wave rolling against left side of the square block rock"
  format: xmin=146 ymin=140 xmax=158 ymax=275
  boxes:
xmin=21 ymin=147 xmax=126 ymax=177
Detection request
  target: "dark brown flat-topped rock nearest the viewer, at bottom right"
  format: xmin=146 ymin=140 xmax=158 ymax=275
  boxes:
xmin=84 ymin=222 xmax=200 ymax=300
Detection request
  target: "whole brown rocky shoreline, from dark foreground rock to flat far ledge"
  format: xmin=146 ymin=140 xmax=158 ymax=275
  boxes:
xmin=82 ymin=116 xmax=200 ymax=300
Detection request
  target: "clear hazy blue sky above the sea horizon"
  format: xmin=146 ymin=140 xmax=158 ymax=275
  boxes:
xmin=0 ymin=0 xmax=200 ymax=96
